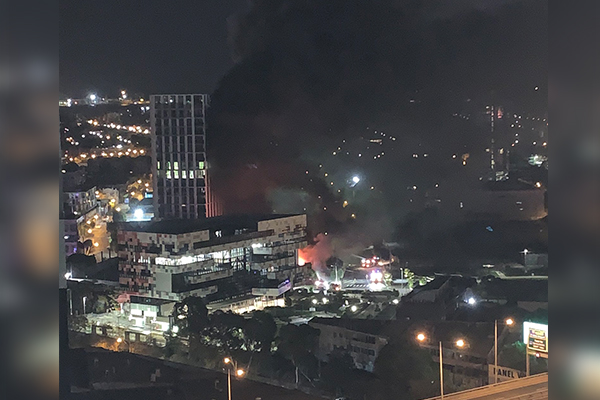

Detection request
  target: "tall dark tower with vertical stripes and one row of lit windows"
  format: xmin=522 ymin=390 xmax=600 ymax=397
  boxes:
xmin=150 ymin=94 xmax=209 ymax=219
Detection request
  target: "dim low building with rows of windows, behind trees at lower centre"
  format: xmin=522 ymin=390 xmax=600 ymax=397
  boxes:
xmin=308 ymin=318 xmax=388 ymax=372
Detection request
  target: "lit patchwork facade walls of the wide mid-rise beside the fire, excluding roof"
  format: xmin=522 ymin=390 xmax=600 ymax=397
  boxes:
xmin=118 ymin=216 xmax=308 ymax=300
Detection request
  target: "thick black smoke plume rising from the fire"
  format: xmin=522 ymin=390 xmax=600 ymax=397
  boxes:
xmin=207 ymin=0 xmax=547 ymax=244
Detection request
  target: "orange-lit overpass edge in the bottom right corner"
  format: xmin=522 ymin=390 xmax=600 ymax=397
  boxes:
xmin=427 ymin=373 xmax=548 ymax=400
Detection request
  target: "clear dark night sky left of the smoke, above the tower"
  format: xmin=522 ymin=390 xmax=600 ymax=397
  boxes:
xmin=60 ymin=0 xmax=248 ymax=97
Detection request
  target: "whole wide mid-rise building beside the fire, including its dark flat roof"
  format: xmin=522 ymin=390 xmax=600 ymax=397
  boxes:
xmin=118 ymin=214 xmax=309 ymax=302
